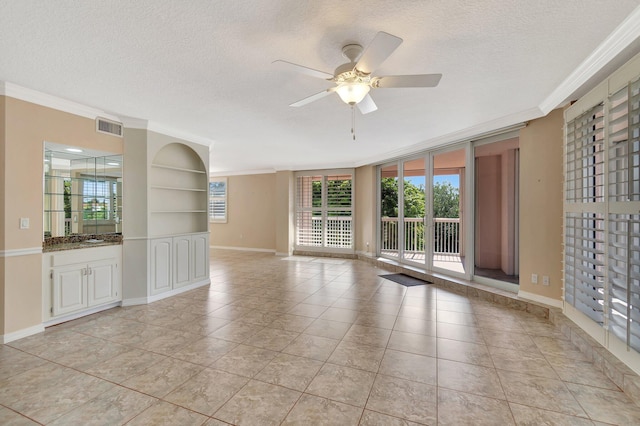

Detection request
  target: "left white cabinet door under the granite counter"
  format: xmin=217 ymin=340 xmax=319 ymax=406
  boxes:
xmin=53 ymin=265 xmax=87 ymax=315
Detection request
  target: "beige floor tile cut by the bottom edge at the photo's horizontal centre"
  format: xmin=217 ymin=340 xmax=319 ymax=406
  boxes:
xmin=282 ymin=394 xmax=362 ymax=426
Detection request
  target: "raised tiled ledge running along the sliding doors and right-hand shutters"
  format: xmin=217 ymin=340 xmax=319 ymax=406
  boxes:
xmin=294 ymin=252 xmax=640 ymax=406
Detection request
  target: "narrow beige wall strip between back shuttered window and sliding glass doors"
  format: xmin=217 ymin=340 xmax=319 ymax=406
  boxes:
xmin=354 ymin=166 xmax=378 ymax=256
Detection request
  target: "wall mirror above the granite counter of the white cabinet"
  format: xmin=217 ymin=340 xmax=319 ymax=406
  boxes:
xmin=43 ymin=142 xmax=122 ymax=238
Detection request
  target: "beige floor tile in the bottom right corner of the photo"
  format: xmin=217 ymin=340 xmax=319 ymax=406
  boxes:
xmin=567 ymin=383 xmax=640 ymax=425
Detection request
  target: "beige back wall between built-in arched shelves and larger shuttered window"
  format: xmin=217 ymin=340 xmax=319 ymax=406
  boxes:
xmin=210 ymin=173 xmax=277 ymax=250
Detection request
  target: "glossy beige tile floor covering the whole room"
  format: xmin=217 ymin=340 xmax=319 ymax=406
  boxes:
xmin=0 ymin=250 xmax=640 ymax=426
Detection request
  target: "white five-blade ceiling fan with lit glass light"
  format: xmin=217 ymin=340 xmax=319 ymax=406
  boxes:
xmin=273 ymin=31 xmax=442 ymax=114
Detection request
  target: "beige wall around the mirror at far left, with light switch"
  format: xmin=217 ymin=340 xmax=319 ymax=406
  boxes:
xmin=0 ymin=97 xmax=123 ymax=334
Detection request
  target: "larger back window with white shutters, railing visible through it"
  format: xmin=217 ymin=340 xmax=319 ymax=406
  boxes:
xmin=295 ymin=173 xmax=353 ymax=250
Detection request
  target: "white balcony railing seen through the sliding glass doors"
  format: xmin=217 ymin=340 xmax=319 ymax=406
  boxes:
xmin=381 ymin=217 xmax=460 ymax=256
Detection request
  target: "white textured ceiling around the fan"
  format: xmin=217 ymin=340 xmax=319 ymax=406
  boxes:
xmin=0 ymin=0 xmax=640 ymax=173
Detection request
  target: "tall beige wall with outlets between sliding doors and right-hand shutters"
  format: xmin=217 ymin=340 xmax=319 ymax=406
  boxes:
xmin=520 ymin=109 xmax=564 ymax=300
